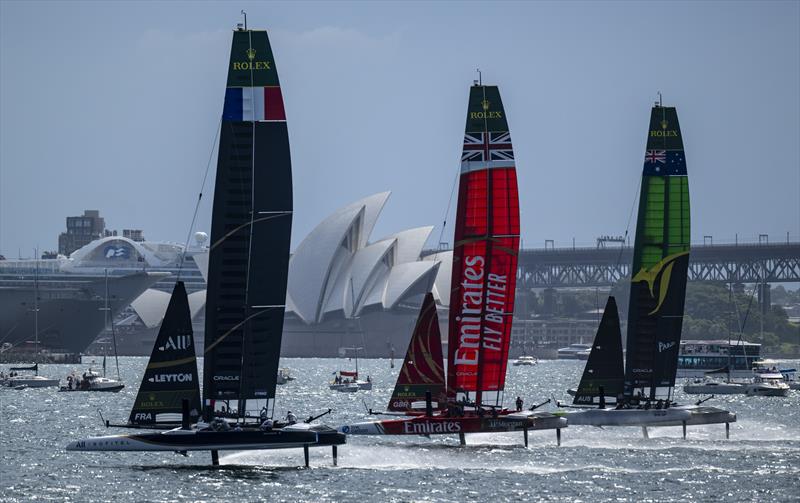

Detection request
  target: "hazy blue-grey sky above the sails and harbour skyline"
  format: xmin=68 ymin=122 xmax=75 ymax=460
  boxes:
xmin=0 ymin=0 xmax=800 ymax=257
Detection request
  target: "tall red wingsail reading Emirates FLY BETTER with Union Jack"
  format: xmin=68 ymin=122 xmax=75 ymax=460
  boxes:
xmin=447 ymin=85 xmax=519 ymax=404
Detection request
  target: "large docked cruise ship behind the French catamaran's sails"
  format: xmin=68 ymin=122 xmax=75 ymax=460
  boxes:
xmin=0 ymin=236 xmax=205 ymax=353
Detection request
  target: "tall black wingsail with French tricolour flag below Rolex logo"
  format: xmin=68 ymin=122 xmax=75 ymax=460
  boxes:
xmin=204 ymin=30 xmax=292 ymax=416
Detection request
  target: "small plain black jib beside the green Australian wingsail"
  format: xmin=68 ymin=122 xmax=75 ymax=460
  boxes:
xmin=572 ymin=297 xmax=625 ymax=405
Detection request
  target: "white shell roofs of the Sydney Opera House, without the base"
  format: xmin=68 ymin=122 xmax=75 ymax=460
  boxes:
xmin=286 ymin=192 xmax=439 ymax=324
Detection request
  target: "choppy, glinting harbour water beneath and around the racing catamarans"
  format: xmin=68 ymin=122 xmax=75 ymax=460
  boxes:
xmin=0 ymin=357 xmax=800 ymax=503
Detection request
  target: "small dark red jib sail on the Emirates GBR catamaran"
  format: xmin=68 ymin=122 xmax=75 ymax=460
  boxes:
xmin=387 ymin=292 xmax=445 ymax=411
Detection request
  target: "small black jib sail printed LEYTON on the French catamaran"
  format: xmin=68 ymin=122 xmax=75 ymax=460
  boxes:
xmin=128 ymin=281 xmax=200 ymax=425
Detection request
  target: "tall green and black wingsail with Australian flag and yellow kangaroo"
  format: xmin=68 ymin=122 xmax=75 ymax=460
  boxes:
xmin=624 ymin=105 xmax=690 ymax=400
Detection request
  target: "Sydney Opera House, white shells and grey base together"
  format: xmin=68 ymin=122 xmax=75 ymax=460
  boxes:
xmin=282 ymin=192 xmax=452 ymax=357
